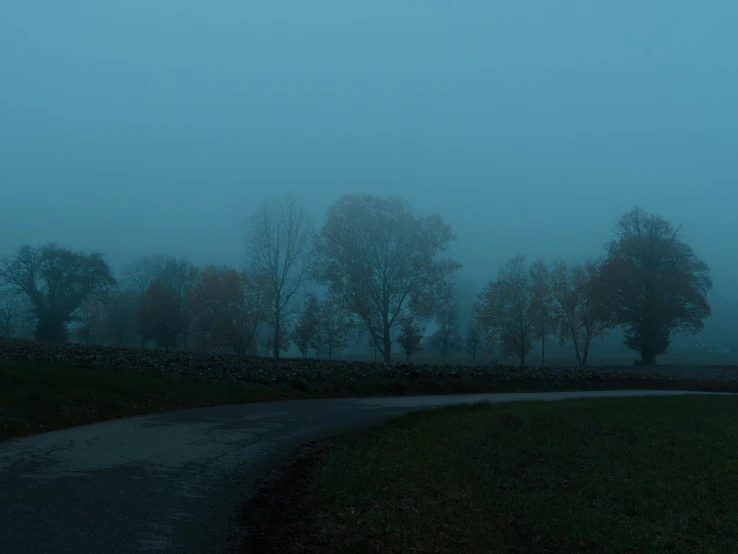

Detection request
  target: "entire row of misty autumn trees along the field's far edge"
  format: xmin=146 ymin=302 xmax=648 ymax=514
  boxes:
xmin=0 ymin=195 xmax=712 ymax=366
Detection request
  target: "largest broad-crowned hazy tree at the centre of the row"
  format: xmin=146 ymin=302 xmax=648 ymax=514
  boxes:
xmin=313 ymin=195 xmax=460 ymax=363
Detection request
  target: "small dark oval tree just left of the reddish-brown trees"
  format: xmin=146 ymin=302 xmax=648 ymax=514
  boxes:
xmin=138 ymin=279 xmax=178 ymax=350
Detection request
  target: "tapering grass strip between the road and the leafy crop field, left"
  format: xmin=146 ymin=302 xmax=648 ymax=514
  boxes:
xmin=0 ymin=362 xmax=299 ymax=440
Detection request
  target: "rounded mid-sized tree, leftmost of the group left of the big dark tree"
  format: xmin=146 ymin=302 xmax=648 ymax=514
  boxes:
xmin=476 ymin=254 xmax=535 ymax=367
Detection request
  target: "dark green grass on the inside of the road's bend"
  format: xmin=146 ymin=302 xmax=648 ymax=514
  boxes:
xmin=307 ymin=397 xmax=738 ymax=554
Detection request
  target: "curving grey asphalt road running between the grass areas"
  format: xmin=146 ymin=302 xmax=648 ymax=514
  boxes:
xmin=0 ymin=391 xmax=724 ymax=554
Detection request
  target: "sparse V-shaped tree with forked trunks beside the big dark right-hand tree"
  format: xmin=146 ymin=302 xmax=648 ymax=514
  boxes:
xmin=549 ymin=261 xmax=609 ymax=366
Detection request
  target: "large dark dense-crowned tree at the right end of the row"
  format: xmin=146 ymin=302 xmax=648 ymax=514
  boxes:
xmin=596 ymin=207 xmax=712 ymax=365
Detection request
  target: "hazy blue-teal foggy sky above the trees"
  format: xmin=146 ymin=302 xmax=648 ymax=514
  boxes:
xmin=0 ymin=0 xmax=738 ymax=297
